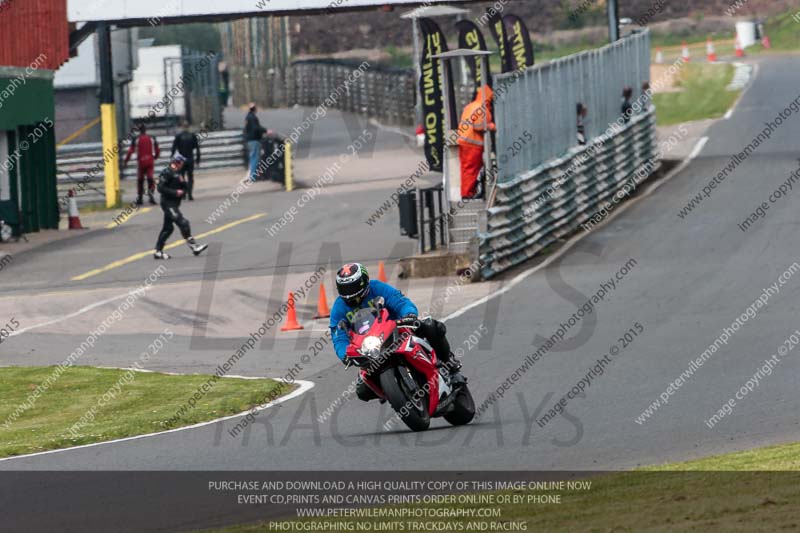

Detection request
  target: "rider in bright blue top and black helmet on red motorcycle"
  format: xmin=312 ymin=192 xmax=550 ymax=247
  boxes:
xmin=330 ymin=263 xmax=461 ymax=402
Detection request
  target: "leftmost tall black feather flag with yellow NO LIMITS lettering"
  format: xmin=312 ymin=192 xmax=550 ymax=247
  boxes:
xmin=419 ymin=18 xmax=458 ymax=172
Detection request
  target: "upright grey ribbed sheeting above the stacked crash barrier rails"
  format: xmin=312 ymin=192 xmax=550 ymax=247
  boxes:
xmin=494 ymin=30 xmax=650 ymax=181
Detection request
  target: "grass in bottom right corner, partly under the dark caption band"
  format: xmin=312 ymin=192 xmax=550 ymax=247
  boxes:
xmin=209 ymin=438 xmax=800 ymax=533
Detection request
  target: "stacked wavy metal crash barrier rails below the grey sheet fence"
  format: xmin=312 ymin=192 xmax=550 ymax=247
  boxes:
xmin=478 ymin=106 xmax=659 ymax=279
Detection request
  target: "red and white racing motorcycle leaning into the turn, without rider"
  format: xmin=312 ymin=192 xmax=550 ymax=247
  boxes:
xmin=339 ymin=298 xmax=475 ymax=431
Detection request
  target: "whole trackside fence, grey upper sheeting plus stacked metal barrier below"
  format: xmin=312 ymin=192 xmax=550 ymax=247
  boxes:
xmin=478 ymin=31 xmax=660 ymax=278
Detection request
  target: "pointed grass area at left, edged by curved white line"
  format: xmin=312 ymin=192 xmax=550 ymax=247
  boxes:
xmin=0 ymin=366 xmax=294 ymax=457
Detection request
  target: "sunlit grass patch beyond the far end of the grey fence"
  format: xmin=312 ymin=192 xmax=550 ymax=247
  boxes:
xmin=653 ymin=63 xmax=741 ymax=126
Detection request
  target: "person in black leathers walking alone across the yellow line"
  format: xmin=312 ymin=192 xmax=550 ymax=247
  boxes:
xmin=153 ymin=153 xmax=208 ymax=259
